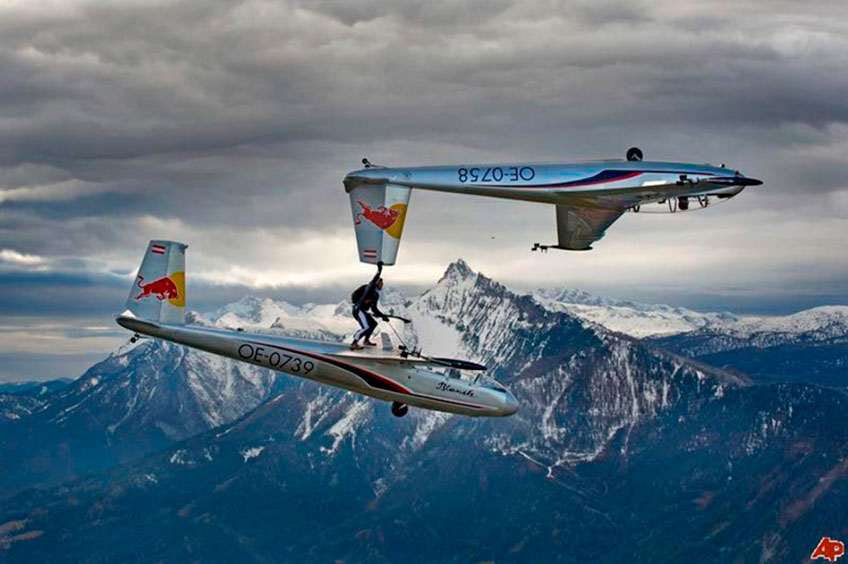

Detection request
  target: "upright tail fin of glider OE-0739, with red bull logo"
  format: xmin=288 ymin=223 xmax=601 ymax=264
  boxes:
xmin=127 ymin=241 xmax=188 ymax=325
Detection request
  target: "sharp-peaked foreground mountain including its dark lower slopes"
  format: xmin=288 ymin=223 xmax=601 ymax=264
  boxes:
xmin=0 ymin=262 xmax=848 ymax=562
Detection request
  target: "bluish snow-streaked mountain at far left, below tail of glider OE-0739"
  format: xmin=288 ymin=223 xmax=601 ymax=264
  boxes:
xmin=0 ymin=334 xmax=276 ymax=494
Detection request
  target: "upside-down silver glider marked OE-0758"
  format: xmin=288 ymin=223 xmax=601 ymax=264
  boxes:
xmin=344 ymin=147 xmax=762 ymax=265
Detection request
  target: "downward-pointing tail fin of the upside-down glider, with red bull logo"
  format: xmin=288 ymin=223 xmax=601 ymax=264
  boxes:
xmin=350 ymin=184 xmax=412 ymax=266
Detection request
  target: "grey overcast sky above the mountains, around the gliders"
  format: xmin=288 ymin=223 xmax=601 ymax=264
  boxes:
xmin=0 ymin=0 xmax=848 ymax=380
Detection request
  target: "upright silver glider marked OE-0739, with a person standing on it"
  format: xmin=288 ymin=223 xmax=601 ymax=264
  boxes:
xmin=116 ymin=241 xmax=518 ymax=417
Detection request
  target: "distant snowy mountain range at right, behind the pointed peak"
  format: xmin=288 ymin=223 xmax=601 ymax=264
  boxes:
xmin=534 ymin=290 xmax=848 ymax=386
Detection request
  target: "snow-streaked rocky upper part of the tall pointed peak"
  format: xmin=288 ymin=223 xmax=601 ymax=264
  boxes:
xmin=400 ymin=260 xmax=747 ymax=468
